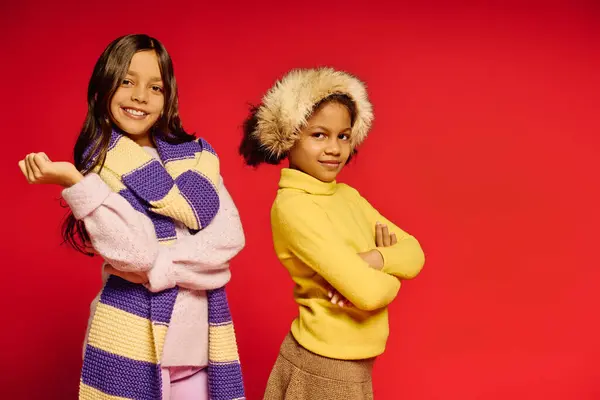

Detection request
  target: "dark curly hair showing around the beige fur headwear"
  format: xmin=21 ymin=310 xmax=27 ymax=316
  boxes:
xmin=238 ymin=93 xmax=357 ymax=167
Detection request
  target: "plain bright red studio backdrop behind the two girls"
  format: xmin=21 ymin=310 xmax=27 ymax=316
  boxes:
xmin=0 ymin=1 xmax=600 ymax=400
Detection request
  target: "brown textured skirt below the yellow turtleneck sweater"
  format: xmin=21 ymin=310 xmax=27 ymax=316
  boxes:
xmin=264 ymin=333 xmax=375 ymax=400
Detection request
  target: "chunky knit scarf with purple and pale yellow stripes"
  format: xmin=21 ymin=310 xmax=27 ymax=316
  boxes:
xmin=79 ymin=132 xmax=245 ymax=400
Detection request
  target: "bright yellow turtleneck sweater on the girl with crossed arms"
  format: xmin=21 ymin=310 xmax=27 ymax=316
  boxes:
xmin=271 ymin=168 xmax=425 ymax=360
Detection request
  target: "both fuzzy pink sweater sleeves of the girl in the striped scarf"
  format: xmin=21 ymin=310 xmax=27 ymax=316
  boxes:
xmin=63 ymin=174 xmax=245 ymax=292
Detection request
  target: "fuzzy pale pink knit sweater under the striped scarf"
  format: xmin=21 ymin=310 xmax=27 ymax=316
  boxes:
xmin=63 ymin=149 xmax=245 ymax=367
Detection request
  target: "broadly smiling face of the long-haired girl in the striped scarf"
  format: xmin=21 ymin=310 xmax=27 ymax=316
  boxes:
xmin=110 ymin=50 xmax=165 ymax=146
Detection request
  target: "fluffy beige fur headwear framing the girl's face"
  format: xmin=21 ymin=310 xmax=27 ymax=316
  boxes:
xmin=253 ymin=68 xmax=373 ymax=158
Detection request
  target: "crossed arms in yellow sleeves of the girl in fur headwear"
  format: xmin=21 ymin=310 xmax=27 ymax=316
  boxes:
xmin=271 ymin=196 xmax=423 ymax=310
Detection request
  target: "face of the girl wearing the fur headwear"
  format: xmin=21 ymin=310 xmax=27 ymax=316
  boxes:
xmin=288 ymin=102 xmax=352 ymax=182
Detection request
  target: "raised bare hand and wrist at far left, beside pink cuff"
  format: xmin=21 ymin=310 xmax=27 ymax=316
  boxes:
xmin=19 ymin=153 xmax=83 ymax=188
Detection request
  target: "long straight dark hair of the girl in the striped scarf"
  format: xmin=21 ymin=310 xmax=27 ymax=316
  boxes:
xmin=62 ymin=34 xmax=194 ymax=255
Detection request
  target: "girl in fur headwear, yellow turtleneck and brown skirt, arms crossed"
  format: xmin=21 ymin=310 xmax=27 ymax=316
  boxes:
xmin=240 ymin=68 xmax=424 ymax=400
